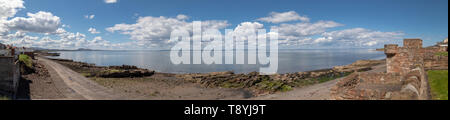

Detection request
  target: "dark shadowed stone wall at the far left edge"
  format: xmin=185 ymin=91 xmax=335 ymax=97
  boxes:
xmin=0 ymin=56 xmax=20 ymax=98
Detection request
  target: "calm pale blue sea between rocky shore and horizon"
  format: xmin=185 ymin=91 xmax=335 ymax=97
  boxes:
xmin=50 ymin=49 xmax=385 ymax=73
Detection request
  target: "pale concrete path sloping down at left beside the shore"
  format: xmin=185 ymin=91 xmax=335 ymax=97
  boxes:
xmin=38 ymin=57 xmax=126 ymax=100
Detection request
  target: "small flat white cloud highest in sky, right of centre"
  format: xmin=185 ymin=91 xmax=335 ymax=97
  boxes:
xmin=258 ymin=11 xmax=309 ymax=23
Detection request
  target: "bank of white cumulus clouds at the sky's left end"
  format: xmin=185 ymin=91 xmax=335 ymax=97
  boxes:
xmin=0 ymin=0 xmax=118 ymax=49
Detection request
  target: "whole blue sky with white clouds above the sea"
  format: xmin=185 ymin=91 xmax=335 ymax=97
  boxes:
xmin=0 ymin=0 xmax=448 ymax=50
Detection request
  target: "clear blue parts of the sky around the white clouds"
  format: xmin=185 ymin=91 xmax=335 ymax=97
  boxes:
xmin=1 ymin=0 xmax=448 ymax=48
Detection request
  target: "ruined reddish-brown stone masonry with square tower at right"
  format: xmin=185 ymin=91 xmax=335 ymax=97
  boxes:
xmin=332 ymin=39 xmax=448 ymax=100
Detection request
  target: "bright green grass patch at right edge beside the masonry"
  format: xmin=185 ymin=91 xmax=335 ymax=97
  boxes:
xmin=428 ymin=70 xmax=448 ymax=100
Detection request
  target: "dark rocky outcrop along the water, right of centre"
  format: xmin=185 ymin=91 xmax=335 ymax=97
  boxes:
xmin=177 ymin=64 xmax=374 ymax=96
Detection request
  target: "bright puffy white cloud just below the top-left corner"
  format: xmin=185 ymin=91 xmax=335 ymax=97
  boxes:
xmin=6 ymin=11 xmax=61 ymax=33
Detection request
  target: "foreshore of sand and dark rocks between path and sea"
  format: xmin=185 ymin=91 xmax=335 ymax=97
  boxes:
xmin=41 ymin=54 xmax=385 ymax=99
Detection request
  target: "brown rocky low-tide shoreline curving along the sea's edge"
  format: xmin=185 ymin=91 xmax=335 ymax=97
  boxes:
xmin=44 ymin=54 xmax=385 ymax=97
